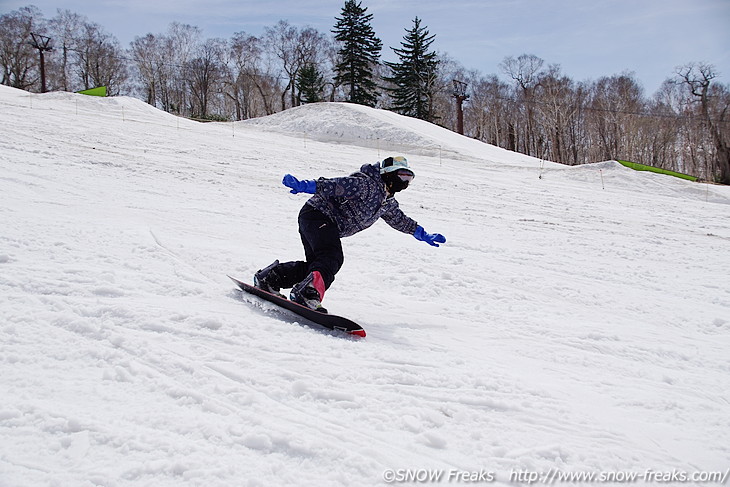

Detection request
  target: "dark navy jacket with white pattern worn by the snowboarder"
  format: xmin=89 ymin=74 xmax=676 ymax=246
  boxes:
xmin=307 ymin=163 xmax=418 ymax=237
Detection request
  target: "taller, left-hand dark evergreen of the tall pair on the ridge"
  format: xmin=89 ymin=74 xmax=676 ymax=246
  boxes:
xmin=332 ymin=0 xmax=383 ymax=107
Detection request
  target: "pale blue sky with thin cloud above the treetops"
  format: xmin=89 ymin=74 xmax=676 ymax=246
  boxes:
xmin=5 ymin=0 xmax=730 ymax=95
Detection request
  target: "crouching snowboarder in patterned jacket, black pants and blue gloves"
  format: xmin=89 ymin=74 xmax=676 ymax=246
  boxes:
xmin=254 ymin=156 xmax=446 ymax=313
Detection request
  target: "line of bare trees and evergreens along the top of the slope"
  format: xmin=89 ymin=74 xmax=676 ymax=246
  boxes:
xmin=0 ymin=0 xmax=730 ymax=184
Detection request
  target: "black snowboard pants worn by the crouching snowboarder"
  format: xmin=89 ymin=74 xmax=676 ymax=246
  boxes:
xmin=276 ymin=204 xmax=345 ymax=289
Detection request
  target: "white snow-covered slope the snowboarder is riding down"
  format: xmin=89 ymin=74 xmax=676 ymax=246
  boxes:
xmin=0 ymin=86 xmax=730 ymax=487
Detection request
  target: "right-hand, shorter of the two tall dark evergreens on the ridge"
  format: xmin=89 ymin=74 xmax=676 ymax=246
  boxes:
xmin=383 ymin=17 xmax=440 ymax=122
